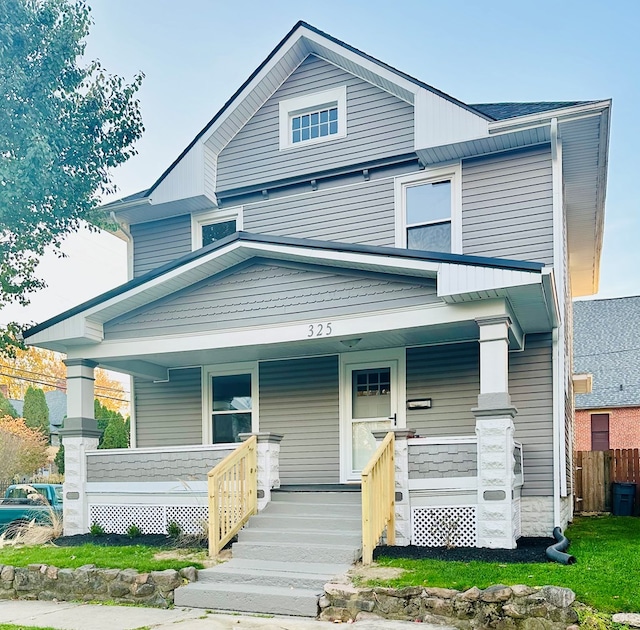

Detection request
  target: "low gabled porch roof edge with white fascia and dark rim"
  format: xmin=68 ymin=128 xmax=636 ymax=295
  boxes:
xmin=24 ymin=232 xmax=556 ymax=360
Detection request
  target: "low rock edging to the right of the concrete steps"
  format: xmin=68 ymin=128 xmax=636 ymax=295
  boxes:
xmin=319 ymin=583 xmax=578 ymax=630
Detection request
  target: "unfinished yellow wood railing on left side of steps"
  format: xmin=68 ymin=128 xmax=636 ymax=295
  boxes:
xmin=208 ymin=435 xmax=258 ymax=556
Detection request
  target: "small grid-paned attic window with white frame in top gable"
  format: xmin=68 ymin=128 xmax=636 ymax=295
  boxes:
xmin=280 ymin=86 xmax=347 ymax=150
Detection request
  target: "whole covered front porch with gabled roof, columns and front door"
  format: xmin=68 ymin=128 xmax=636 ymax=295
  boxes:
xmin=22 ymin=234 xmax=556 ymax=547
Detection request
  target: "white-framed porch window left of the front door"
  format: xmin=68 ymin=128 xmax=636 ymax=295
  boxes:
xmin=203 ymin=363 xmax=257 ymax=444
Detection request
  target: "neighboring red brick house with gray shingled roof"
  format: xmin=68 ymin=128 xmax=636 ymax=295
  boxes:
xmin=573 ymin=296 xmax=640 ymax=451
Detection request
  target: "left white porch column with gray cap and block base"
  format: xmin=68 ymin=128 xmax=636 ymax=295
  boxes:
xmin=60 ymin=359 xmax=100 ymax=536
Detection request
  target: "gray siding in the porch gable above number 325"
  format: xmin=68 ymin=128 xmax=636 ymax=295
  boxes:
xmin=105 ymin=264 xmax=439 ymax=339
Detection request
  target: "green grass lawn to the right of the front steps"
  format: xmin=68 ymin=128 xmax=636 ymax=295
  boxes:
xmin=371 ymin=516 xmax=640 ymax=612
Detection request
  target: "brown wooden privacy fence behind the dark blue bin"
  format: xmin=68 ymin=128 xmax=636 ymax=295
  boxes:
xmin=574 ymin=448 xmax=640 ymax=514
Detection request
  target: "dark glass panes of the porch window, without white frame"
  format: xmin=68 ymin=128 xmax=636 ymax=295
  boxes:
xmin=211 ymin=374 xmax=253 ymax=444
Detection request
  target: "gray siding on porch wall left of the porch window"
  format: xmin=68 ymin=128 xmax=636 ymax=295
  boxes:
xmin=134 ymin=368 xmax=202 ymax=448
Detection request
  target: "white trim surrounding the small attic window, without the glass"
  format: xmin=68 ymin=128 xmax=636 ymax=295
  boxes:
xmin=279 ymin=85 xmax=347 ymax=151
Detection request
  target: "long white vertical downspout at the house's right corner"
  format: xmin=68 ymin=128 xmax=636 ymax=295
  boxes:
xmin=550 ymin=118 xmax=566 ymax=527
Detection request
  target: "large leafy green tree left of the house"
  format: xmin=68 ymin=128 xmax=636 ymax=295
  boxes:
xmin=0 ymin=0 xmax=143 ymax=354
